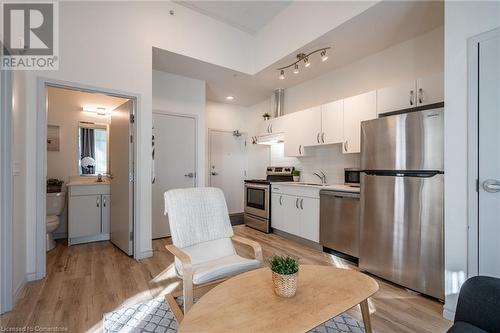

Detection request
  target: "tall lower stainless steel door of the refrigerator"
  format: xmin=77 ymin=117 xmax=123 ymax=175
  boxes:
xmin=359 ymin=174 xmax=444 ymax=299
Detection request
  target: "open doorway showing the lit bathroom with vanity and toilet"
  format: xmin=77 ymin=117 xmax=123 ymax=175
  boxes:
xmin=37 ymin=82 xmax=137 ymax=278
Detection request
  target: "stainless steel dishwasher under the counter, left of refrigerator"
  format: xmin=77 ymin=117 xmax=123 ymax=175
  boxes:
xmin=319 ymin=190 xmax=360 ymax=258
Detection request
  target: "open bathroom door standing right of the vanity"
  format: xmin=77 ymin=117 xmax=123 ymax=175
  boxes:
xmin=109 ymin=101 xmax=134 ymax=256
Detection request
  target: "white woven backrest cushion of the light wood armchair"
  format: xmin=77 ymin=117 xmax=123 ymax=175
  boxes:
xmin=164 ymin=187 xmax=233 ymax=249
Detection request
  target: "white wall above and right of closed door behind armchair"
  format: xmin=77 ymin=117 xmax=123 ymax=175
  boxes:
xmin=152 ymin=71 xmax=207 ymax=185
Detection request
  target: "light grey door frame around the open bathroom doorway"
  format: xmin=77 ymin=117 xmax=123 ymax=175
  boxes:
xmin=35 ymin=77 xmax=141 ymax=280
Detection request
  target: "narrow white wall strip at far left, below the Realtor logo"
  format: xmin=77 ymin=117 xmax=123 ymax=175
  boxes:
xmin=12 ymin=71 xmax=27 ymax=294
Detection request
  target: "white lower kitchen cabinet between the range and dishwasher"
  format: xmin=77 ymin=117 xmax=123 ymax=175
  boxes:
xmin=271 ymin=187 xmax=319 ymax=243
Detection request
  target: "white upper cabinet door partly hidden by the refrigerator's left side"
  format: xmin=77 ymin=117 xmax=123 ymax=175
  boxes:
xmin=342 ymin=91 xmax=377 ymax=153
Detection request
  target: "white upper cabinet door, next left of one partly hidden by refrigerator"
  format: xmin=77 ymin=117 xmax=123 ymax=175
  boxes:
xmin=317 ymin=100 xmax=344 ymax=144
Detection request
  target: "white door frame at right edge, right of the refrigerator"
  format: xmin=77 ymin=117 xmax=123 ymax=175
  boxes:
xmin=467 ymin=28 xmax=500 ymax=277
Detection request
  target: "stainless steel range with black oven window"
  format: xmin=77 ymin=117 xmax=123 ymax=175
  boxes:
xmin=244 ymin=167 xmax=294 ymax=233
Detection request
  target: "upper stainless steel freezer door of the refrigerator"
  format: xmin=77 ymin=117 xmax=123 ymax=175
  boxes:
xmin=361 ymin=108 xmax=444 ymax=171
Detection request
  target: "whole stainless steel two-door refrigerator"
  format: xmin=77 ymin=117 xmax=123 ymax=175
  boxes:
xmin=359 ymin=108 xmax=444 ymax=299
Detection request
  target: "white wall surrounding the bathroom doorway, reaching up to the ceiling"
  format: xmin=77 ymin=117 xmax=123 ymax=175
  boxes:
xmin=16 ymin=1 xmax=266 ymax=273
